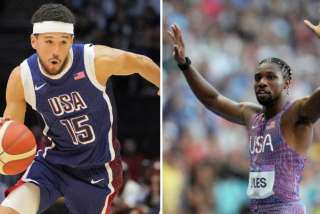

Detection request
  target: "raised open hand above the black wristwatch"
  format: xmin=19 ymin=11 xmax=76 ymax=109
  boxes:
xmin=167 ymin=23 xmax=186 ymax=65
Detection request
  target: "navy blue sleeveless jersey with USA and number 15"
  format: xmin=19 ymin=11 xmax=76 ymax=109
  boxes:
xmin=21 ymin=44 xmax=120 ymax=167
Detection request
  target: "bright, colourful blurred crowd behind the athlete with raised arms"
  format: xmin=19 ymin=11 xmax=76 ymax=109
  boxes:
xmin=162 ymin=0 xmax=320 ymax=214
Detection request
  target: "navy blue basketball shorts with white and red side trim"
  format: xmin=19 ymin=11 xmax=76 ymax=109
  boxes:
xmin=5 ymin=151 xmax=122 ymax=214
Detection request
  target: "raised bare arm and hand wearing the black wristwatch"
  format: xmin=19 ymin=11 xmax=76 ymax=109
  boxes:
xmin=168 ymin=24 xmax=261 ymax=126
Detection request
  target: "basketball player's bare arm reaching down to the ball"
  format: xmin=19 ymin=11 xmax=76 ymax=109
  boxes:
xmin=3 ymin=66 xmax=27 ymax=123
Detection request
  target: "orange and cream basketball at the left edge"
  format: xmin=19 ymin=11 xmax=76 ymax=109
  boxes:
xmin=0 ymin=120 xmax=37 ymax=175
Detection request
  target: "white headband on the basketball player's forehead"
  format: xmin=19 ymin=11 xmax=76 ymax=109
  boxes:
xmin=33 ymin=21 xmax=74 ymax=34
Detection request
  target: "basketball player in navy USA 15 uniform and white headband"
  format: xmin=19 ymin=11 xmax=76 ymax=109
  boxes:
xmin=0 ymin=4 xmax=160 ymax=214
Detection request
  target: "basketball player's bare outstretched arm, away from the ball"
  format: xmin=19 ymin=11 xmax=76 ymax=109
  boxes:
xmin=94 ymin=45 xmax=160 ymax=92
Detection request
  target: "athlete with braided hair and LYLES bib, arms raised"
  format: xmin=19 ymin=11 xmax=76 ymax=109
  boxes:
xmin=168 ymin=19 xmax=320 ymax=214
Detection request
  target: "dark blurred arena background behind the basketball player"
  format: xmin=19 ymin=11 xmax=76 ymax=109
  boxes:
xmin=0 ymin=0 xmax=161 ymax=214
